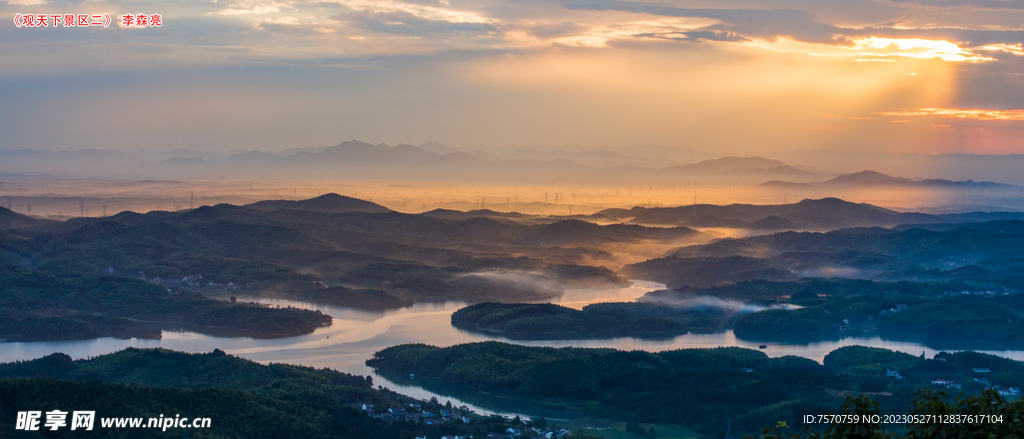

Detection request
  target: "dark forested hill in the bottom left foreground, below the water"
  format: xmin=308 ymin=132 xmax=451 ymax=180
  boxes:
xmin=0 ymin=348 xmax=521 ymax=439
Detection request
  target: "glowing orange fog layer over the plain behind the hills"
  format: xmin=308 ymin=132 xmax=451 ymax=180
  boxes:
xmin=0 ymin=175 xmax=1024 ymax=222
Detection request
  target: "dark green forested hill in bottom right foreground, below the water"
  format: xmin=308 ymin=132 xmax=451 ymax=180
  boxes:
xmin=367 ymin=342 xmax=1024 ymax=438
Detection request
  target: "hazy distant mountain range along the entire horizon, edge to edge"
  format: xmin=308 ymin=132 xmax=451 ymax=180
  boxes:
xmin=0 ymin=140 xmax=1024 ymax=188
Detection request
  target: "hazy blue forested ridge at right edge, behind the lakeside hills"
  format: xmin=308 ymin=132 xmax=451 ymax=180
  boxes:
xmin=621 ymin=221 xmax=1024 ymax=288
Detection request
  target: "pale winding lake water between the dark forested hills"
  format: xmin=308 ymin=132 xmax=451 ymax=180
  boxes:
xmin=6 ymin=280 xmax=1024 ymax=415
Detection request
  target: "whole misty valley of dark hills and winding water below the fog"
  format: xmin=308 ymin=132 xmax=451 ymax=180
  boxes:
xmin=0 ymin=179 xmax=1024 ymax=438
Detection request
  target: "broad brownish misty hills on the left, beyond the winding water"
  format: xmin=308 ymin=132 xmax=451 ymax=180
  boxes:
xmin=0 ymin=194 xmax=710 ymax=308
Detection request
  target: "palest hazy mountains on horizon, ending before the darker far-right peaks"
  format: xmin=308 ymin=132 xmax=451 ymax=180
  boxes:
xmin=0 ymin=140 xmax=813 ymax=184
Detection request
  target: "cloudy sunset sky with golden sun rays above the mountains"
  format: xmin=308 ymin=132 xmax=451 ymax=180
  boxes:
xmin=0 ymin=0 xmax=1024 ymax=155
